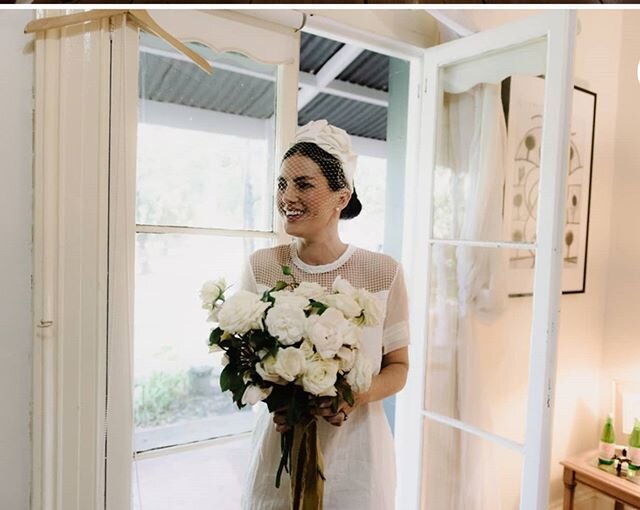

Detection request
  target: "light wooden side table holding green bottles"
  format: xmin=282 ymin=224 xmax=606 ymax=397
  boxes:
xmin=560 ymin=450 xmax=640 ymax=510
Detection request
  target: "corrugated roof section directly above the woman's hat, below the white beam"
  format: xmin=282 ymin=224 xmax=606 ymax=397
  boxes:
xmin=298 ymin=94 xmax=387 ymax=140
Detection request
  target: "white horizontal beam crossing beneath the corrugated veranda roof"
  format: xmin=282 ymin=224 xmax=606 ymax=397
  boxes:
xmin=140 ymin=45 xmax=389 ymax=110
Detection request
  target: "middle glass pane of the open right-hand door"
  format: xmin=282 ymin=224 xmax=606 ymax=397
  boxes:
xmin=425 ymin=245 xmax=533 ymax=442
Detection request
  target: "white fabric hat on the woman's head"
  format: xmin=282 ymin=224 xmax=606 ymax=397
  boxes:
xmin=296 ymin=119 xmax=358 ymax=190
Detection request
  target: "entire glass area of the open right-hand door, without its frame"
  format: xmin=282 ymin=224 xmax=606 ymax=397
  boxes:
xmin=422 ymin=18 xmax=572 ymax=510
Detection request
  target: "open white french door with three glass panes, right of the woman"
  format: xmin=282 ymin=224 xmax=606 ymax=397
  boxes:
xmin=396 ymin=11 xmax=576 ymax=510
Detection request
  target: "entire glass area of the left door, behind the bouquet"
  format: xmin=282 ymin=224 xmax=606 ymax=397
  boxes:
xmin=132 ymin=30 xmax=277 ymax=510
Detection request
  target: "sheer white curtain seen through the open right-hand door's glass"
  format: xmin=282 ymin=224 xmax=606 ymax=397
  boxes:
xmin=426 ymin=84 xmax=506 ymax=510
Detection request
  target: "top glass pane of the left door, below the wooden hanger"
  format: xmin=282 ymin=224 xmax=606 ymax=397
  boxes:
xmin=136 ymin=35 xmax=277 ymax=231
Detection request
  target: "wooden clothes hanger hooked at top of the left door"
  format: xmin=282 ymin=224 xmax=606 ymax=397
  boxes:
xmin=24 ymin=9 xmax=213 ymax=74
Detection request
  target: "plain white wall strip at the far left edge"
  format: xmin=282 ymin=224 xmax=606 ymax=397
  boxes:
xmin=0 ymin=11 xmax=33 ymax=510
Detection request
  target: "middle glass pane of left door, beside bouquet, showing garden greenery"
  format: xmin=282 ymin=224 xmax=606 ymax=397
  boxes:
xmin=134 ymin=234 xmax=271 ymax=451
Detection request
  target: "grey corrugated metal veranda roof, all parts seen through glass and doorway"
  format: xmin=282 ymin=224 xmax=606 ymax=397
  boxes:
xmin=140 ymin=33 xmax=389 ymax=140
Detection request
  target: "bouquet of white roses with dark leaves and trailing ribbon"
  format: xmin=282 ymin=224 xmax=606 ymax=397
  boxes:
xmin=200 ymin=266 xmax=381 ymax=509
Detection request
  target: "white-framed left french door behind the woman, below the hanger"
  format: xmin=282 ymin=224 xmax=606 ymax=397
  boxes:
xmin=105 ymin=10 xmax=299 ymax=510
